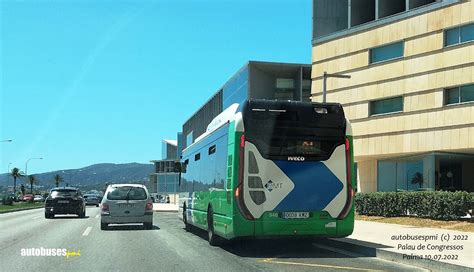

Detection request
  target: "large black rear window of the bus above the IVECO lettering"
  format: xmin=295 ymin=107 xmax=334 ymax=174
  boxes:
xmin=244 ymin=101 xmax=346 ymax=160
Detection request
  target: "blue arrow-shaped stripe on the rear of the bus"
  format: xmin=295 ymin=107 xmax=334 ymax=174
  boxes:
xmin=274 ymin=161 xmax=344 ymax=212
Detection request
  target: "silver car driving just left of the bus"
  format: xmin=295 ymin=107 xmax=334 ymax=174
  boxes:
xmin=100 ymin=184 xmax=153 ymax=230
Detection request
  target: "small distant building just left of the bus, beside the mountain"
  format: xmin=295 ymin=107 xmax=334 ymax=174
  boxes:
xmin=148 ymin=138 xmax=180 ymax=195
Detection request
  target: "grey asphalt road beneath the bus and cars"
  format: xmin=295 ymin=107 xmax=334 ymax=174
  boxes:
xmin=0 ymin=207 xmax=426 ymax=271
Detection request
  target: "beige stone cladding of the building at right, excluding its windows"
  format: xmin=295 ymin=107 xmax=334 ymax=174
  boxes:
xmin=312 ymin=0 xmax=474 ymax=191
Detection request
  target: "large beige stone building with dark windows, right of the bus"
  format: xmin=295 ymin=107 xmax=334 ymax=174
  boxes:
xmin=311 ymin=0 xmax=474 ymax=192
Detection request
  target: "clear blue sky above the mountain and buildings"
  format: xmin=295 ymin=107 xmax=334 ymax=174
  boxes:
xmin=0 ymin=0 xmax=312 ymax=174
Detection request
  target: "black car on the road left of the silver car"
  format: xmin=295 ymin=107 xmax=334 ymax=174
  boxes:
xmin=44 ymin=187 xmax=86 ymax=218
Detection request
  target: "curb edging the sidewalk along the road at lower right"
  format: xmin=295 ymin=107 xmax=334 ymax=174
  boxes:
xmin=323 ymin=238 xmax=472 ymax=271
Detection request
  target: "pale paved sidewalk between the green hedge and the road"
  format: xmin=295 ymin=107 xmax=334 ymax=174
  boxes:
xmin=333 ymin=220 xmax=474 ymax=271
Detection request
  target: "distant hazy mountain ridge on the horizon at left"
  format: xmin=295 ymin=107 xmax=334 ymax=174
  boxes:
xmin=0 ymin=163 xmax=154 ymax=188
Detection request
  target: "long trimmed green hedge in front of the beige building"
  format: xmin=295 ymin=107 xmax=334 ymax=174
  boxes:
xmin=355 ymin=191 xmax=474 ymax=220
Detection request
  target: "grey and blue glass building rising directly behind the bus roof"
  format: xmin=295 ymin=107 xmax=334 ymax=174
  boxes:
xmin=178 ymin=61 xmax=311 ymax=150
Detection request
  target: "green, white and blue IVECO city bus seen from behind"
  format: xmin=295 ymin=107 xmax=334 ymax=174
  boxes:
xmin=179 ymin=100 xmax=356 ymax=245
